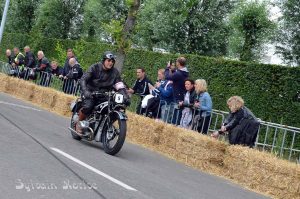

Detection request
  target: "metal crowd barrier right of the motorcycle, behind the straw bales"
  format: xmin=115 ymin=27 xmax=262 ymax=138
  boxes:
xmin=131 ymin=96 xmax=300 ymax=164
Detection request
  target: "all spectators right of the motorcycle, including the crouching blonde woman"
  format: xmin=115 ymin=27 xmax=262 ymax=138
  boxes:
xmin=128 ymin=57 xmax=259 ymax=147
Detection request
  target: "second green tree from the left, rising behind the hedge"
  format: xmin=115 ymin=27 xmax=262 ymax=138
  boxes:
xmin=34 ymin=0 xmax=85 ymax=39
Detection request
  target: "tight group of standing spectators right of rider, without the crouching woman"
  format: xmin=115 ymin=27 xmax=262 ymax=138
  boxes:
xmin=128 ymin=57 xmax=212 ymax=134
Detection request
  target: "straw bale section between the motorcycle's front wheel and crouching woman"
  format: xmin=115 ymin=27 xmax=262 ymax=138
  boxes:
xmin=128 ymin=112 xmax=227 ymax=173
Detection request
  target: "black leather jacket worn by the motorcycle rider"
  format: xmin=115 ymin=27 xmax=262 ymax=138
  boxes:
xmin=80 ymin=63 xmax=122 ymax=93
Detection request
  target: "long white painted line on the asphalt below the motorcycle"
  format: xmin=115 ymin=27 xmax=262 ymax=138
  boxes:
xmin=51 ymin=147 xmax=137 ymax=191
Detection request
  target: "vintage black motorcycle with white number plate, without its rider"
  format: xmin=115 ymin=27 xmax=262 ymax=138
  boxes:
xmin=69 ymin=91 xmax=127 ymax=155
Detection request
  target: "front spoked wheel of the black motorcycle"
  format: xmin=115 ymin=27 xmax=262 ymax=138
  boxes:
xmin=102 ymin=116 xmax=127 ymax=155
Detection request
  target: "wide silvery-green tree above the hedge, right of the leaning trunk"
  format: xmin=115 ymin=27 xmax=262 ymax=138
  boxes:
xmin=135 ymin=0 xmax=235 ymax=56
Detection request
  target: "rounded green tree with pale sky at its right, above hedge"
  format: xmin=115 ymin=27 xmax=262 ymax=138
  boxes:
xmin=229 ymin=1 xmax=276 ymax=61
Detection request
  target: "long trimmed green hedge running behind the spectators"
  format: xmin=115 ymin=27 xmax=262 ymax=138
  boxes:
xmin=0 ymin=34 xmax=300 ymax=127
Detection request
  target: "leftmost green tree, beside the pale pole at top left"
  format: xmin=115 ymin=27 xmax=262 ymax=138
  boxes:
xmin=4 ymin=0 xmax=41 ymax=33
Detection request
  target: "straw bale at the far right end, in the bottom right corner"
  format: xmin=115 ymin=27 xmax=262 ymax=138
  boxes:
xmin=224 ymin=146 xmax=300 ymax=198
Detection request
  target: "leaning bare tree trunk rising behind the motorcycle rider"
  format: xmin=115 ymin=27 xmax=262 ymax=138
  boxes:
xmin=115 ymin=0 xmax=141 ymax=71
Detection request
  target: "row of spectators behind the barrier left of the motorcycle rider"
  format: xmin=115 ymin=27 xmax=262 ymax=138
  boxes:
xmin=6 ymin=46 xmax=83 ymax=94
